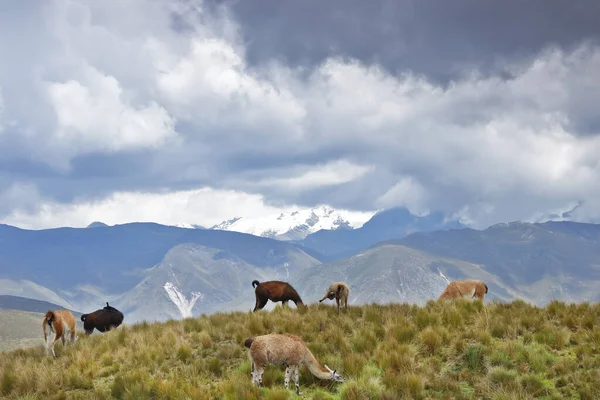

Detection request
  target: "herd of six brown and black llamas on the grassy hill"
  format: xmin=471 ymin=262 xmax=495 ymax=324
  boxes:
xmin=42 ymin=279 xmax=488 ymax=395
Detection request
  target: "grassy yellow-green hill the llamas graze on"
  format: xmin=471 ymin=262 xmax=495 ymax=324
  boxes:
xmin=0 ymin=301 xmax=600 ymax=400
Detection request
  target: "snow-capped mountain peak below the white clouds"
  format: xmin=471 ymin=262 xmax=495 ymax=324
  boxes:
xmin=210 ymin=205 xmax=375 ymax=240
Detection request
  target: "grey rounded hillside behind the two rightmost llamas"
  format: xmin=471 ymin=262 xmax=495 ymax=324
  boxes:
xmin=295 ymin=244 xmax=522 ymax=305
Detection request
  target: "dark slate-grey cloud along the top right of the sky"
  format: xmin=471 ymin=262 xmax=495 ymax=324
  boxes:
xmin=209 ymin=0 xmax=600 ymax=82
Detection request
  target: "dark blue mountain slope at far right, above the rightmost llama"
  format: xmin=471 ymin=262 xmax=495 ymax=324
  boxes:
xmin=390 ymin=222 xmax=600 ymax=304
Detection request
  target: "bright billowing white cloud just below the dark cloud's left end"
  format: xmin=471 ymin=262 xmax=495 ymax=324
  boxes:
xmin=147 ymin=37 xmax=305 ymax=138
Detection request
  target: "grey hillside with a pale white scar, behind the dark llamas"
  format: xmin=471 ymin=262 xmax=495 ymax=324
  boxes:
xmin=119 ymin=243 xmax=320 ymax=323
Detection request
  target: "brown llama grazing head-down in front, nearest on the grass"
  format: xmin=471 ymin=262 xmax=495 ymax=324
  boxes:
xmin=244 ymin=333 xmax=344 ymax=395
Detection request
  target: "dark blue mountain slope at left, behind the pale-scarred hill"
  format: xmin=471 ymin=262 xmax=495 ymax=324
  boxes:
xmin=0 ymin=223 xmax=324 ymax=311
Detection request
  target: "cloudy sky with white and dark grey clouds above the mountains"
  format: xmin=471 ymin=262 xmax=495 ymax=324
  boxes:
xmin=0 ymin=0 xmax=600 ymax=229
